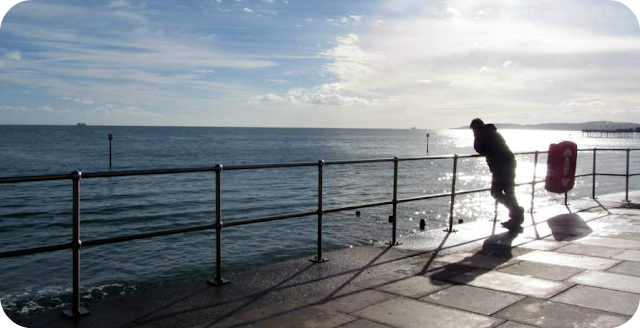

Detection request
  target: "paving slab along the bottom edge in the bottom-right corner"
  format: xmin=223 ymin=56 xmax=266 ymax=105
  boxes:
xmin=493 ymin=297 xmax=631 ymax=328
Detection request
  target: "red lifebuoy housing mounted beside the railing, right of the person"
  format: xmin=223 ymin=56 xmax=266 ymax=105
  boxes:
xmin=544 ymin=141 xmax=578 ymax=193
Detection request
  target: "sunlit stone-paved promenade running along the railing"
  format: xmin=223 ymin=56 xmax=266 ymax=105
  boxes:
xmin=12 ymin=192 xmax=640 ymax=328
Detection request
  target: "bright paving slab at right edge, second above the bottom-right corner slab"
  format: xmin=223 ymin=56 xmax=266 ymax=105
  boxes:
xmin=567 ymin=271 xmax=640 ymax=294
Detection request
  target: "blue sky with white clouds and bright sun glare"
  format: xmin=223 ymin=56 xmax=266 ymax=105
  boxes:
xmin=0 ymin=0 xmax=640 ymax=129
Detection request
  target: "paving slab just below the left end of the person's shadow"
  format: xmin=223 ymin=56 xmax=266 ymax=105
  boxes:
xmin=420 ymin=285 xmax=524 ymax=315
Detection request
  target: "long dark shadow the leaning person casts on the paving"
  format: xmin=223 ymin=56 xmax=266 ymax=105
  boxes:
xmin=430 ymin=231 xmax=520 ymax=282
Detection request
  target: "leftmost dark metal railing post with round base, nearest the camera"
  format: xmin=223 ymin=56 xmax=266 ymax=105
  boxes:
xmin=63 ymin=171 xmax=89 ymax=318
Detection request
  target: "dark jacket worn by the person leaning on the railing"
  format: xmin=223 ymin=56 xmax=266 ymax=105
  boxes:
xmin=473 ymin=124 xmax=516 ymax=172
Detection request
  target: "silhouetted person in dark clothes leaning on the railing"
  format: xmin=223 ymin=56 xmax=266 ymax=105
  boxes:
xmin=470 ymin=118 xmax=524 ymax=230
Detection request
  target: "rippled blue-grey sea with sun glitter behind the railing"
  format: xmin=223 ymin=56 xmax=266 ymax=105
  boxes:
xmin=0 ymin=125 xmax=640 ymax=315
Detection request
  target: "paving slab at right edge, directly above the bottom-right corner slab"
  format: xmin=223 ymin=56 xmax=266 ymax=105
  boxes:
xmin=551 ymin=285 xmax=640 ymax=316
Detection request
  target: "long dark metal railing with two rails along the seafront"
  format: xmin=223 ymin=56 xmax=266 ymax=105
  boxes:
xmin=0 ymin=148 xmax=640 ymax=318
